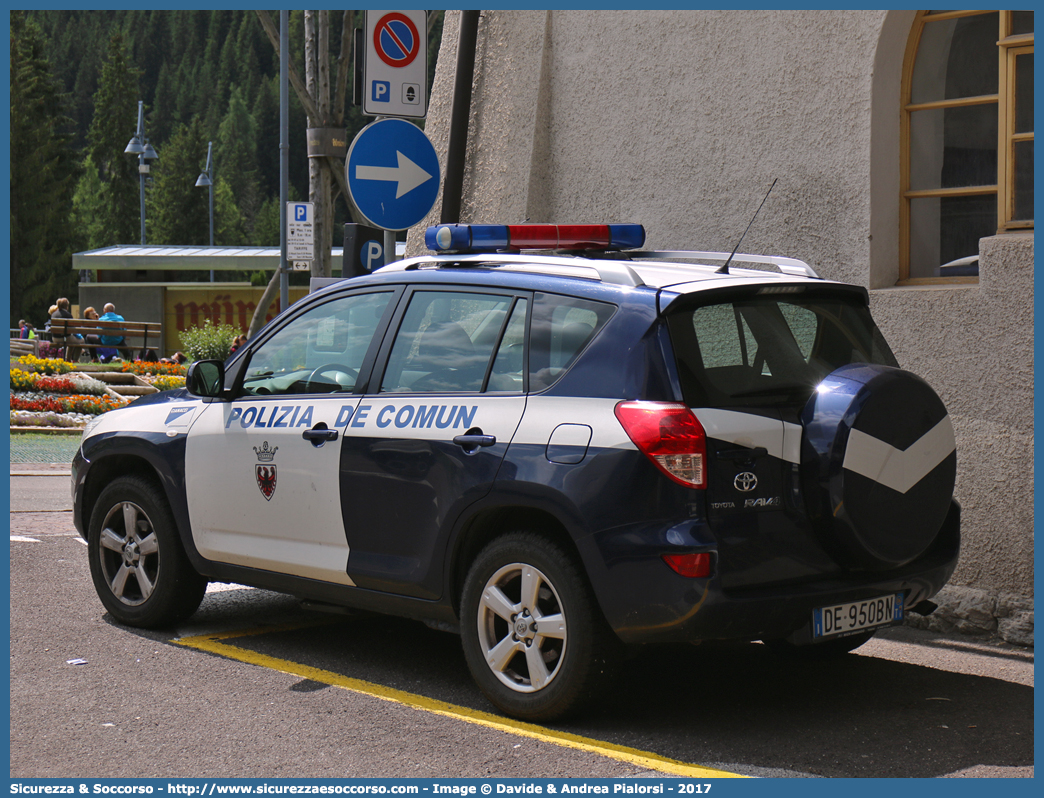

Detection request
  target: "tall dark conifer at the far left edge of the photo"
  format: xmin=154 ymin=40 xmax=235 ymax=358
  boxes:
xmin=10 ymin=11 xmax=77 ymax=325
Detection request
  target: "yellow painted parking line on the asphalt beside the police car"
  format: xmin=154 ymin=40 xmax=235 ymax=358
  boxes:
xmin=172 ymin=621 xmax=746 ymax=778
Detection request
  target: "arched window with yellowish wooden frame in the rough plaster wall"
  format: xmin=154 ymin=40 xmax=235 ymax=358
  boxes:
xmin=899 ymin=11 xmax=1034 ymax=284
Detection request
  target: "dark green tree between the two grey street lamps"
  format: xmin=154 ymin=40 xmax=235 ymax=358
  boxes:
xmin=146 ymin=118 xmax=210 ymax=247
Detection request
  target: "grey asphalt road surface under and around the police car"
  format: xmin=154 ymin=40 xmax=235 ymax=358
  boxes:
xmin=10 ymin=466 xmax=1034 ymax=778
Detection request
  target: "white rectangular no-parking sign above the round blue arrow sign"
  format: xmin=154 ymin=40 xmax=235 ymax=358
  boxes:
xmin=362 ymin=10 xmax=428 ymax=119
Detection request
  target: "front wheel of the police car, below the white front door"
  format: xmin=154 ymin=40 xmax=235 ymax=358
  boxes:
xmin=87 ymin=476 xmax=207 ymax=629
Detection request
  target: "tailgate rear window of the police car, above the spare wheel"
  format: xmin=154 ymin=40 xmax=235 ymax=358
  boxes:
xmin=667 ymin=297 xmax=898 ymax=406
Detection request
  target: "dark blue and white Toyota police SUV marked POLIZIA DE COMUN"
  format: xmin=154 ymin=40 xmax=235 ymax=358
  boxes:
xmin=72 ymin=225 xmax=959 ymax=721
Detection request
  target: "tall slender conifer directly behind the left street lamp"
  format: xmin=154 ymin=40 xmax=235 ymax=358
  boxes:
xmin=87 ymin=33 xmax=140 ymax=244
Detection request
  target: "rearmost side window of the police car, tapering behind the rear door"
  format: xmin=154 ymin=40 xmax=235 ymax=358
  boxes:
xmin=529 ymin=294 xmax=616 ymax=393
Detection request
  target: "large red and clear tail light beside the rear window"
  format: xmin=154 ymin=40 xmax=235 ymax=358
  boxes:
xmin=616 ymin=402 xmax=707 ymax=488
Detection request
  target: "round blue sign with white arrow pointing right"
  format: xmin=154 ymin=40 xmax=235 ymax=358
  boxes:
xmin=345 ymin=119 xmax=440 ymax=230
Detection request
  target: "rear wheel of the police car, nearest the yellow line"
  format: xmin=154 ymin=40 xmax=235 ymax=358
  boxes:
xmin=460 ymin=531 xmax=617 ymax=722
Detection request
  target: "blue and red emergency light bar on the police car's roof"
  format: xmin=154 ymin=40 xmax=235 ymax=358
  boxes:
xmin=424 ymin=225 xmax=645 ymax=253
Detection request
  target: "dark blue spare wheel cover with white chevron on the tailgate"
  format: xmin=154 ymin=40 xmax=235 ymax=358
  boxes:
xmin=801 ymin=363 xmax=957 ymax=569
